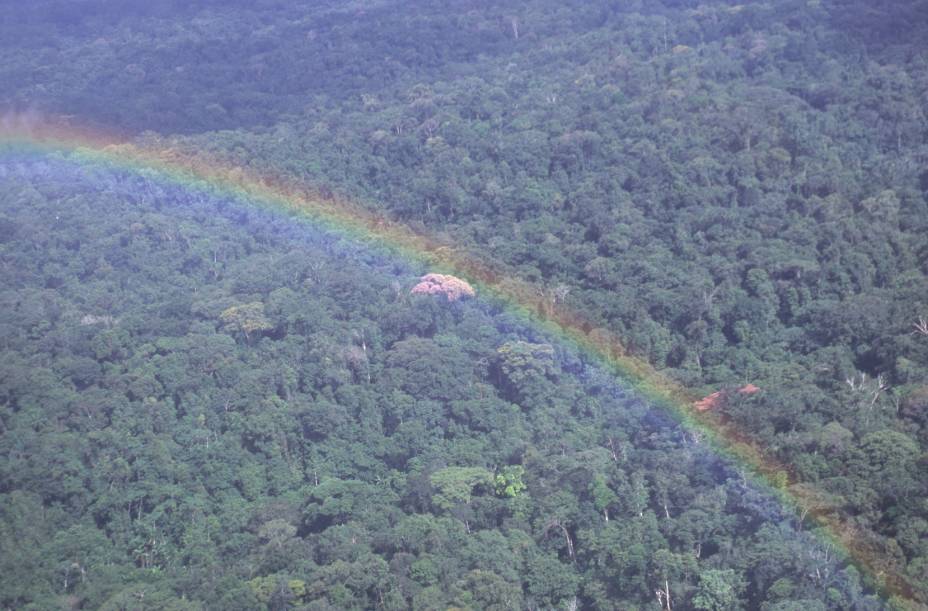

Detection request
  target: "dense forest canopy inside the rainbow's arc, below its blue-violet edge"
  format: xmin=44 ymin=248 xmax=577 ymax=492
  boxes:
xmin=0 ymin=156 xmax=880 ymax=609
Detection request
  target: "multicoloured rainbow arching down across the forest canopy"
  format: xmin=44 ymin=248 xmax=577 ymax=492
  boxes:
xmin=0 ymin=119 xmax=919 ymax=608
